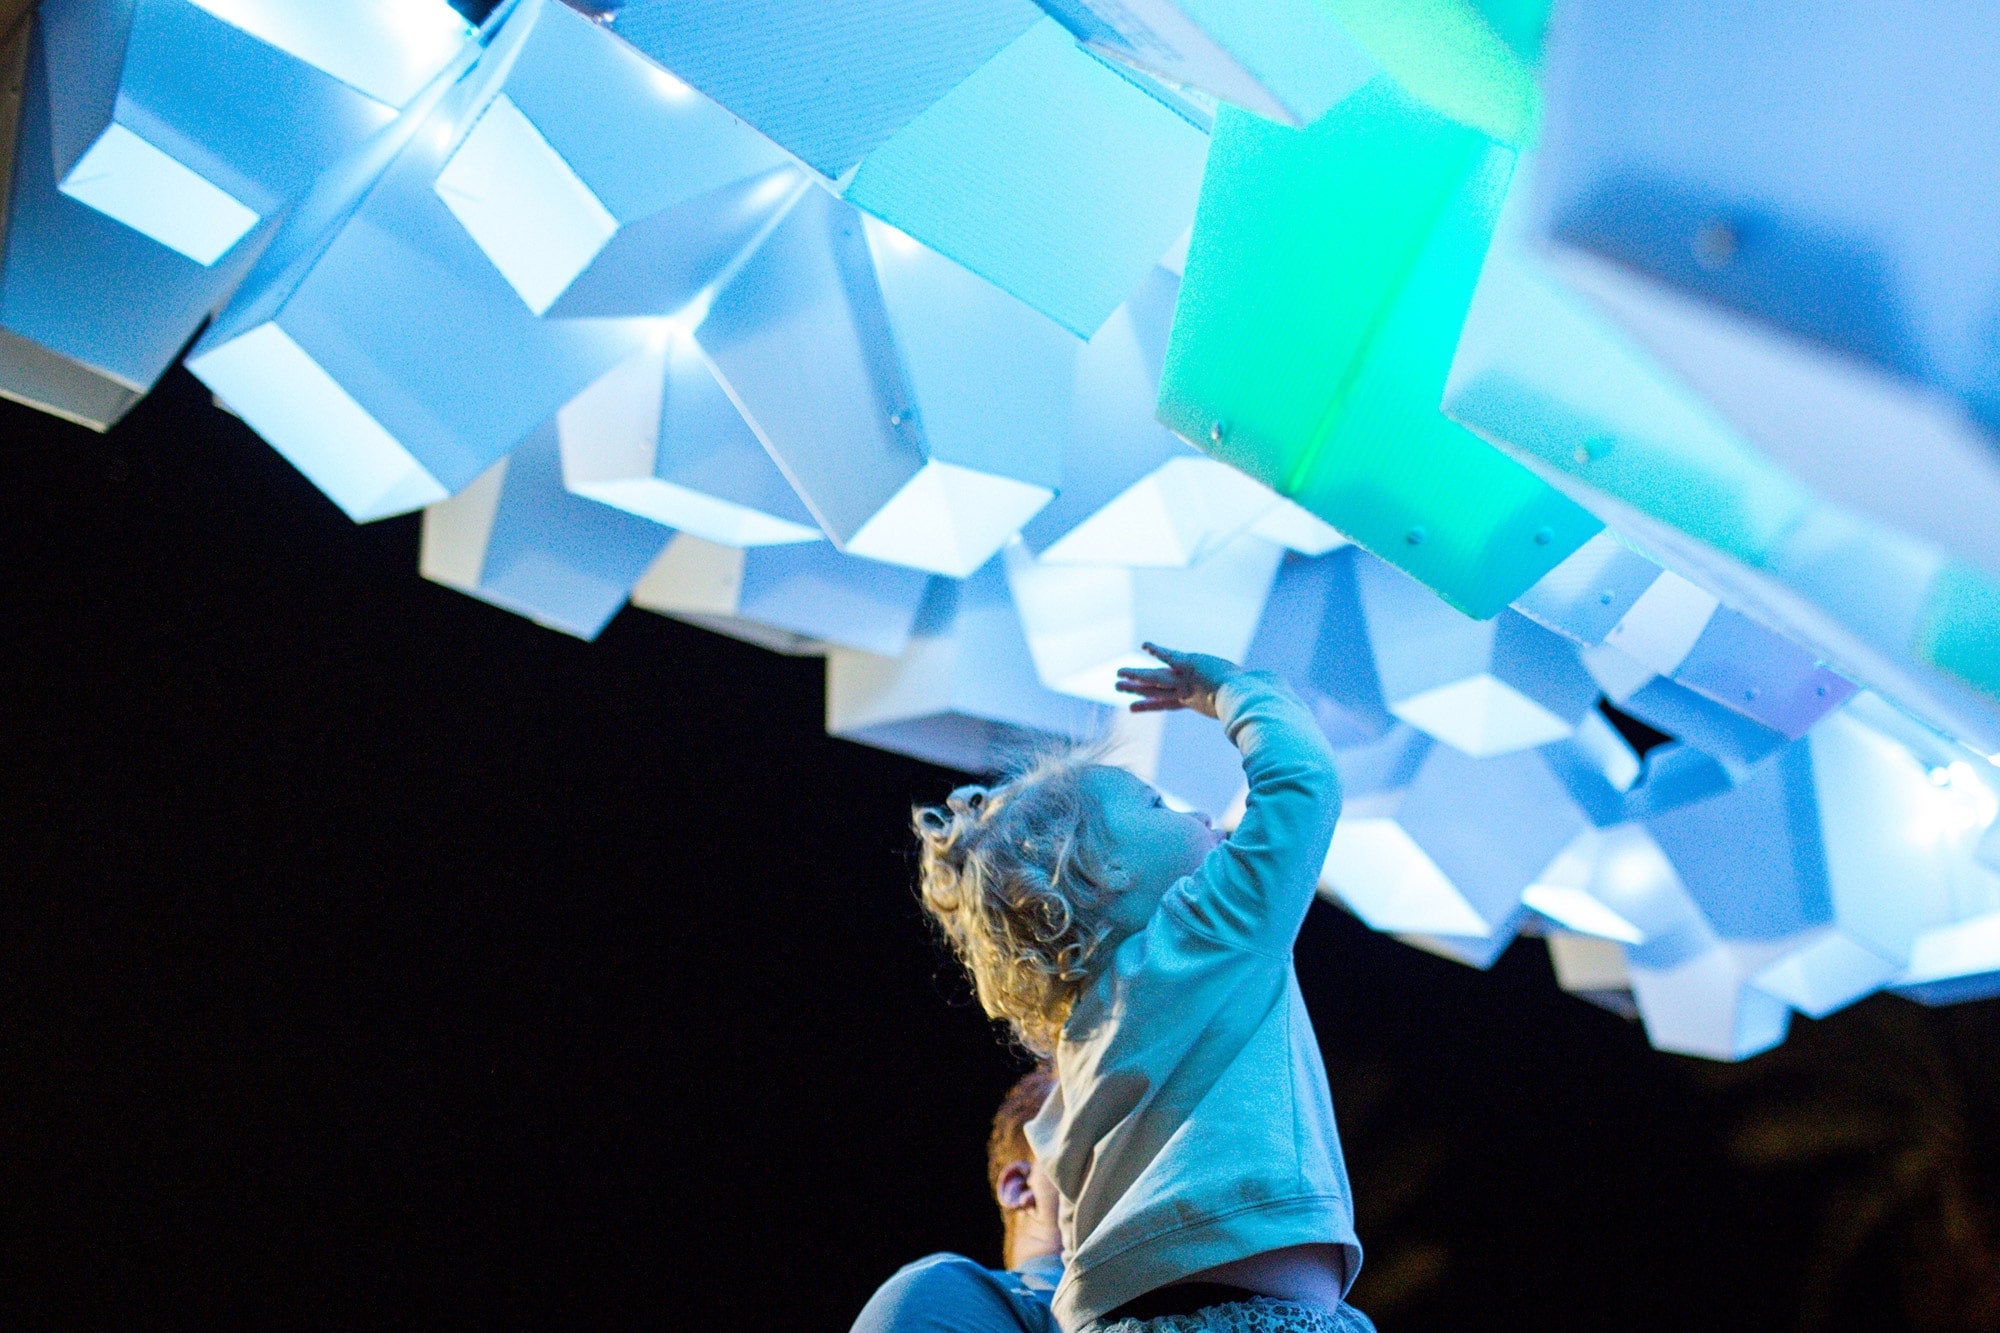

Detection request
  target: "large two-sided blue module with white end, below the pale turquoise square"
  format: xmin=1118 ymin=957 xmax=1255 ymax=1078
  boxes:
xmin=696 ymin=190 xmax=1078 ymax=578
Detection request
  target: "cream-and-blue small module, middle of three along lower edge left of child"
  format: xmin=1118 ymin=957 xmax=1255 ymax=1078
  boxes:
xmin=632 ymin=532 xmax=932 ymax=656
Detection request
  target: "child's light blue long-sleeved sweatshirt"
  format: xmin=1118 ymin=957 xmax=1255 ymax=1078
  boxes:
xmin=1026 ymin=673 xmax=1362 ymax=1333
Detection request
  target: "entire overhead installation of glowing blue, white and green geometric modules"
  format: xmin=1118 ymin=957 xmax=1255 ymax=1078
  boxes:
xmin=23 ymin=0 xmax=2000 ymax=1059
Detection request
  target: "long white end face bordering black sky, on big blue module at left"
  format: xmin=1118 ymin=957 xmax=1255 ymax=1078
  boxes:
xmin=190 ymin=324 xmax=450 ymax=522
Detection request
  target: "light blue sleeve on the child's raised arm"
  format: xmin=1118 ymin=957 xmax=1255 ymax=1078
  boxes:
xmin=1164 ymin=671 xmax=1340 ymax=955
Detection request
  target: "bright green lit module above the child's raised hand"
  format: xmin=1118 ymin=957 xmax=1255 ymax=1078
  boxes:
xmin=1158 ymin=78 xmax=1602 ymax=616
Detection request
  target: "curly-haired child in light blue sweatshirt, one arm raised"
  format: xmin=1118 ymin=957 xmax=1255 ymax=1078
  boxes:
xmin=916 ymin=644 xmax=1374 ymax=1333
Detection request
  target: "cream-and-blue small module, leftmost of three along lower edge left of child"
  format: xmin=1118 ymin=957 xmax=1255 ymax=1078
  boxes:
xmin=420 ymin=426 xmax=672 ymax=638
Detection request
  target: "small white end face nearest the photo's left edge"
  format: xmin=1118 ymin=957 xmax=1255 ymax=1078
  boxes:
xmin=62 ymin=120 xmax=258 ymax=266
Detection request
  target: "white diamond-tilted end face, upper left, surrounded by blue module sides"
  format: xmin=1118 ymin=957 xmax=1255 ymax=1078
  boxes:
xmin=436 ymin=94 xmax=618 ymax=314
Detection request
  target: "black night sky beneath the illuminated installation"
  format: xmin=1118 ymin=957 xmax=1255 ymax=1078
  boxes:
xmin=0 ymin=370 xmax=1968 ymax=1331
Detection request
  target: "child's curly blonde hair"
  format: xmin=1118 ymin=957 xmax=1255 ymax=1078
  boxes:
xmin=912 ymin=747 xmax=1106 ymax=1055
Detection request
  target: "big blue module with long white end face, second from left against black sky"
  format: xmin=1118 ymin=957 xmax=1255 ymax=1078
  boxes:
xmin=188 ymin=2 xmax=652 ymax=520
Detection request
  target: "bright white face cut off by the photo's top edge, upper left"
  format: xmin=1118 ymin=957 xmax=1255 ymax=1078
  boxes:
xmin=188 ymin=0 xmax=472 ymax=108
